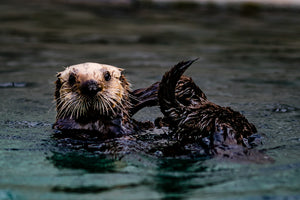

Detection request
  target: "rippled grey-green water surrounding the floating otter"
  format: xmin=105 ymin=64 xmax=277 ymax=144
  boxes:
xmin=0 ymin=1 xmax=300 ymax=200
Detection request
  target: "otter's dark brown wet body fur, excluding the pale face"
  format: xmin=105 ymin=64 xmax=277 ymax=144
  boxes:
xmin=53 ymin=61 xmax=270 ymax=162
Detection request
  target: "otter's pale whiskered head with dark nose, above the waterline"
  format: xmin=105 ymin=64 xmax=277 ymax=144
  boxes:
xmin=55 ymin=63 xmax=129 ymax=120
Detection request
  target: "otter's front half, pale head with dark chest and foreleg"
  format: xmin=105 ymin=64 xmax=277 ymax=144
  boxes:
xmin=53 ymin=63 xmax=158 ymax=138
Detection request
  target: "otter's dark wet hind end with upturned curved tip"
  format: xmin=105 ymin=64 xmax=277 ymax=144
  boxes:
xmin=158 ymin=60 xmax=264 ymax=156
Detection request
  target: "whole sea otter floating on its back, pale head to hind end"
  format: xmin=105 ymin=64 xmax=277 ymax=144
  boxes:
xmin=53 ymin=61 xmax=270 ymax=161
